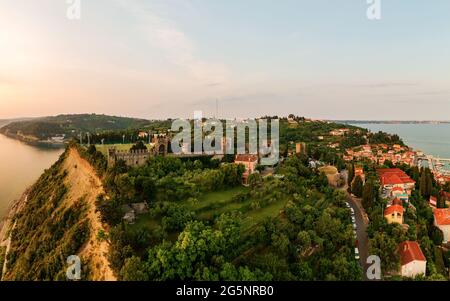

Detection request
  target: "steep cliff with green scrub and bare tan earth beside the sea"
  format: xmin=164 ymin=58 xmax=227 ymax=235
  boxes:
xmin=3 ymin=148 xmax=116 ymax=281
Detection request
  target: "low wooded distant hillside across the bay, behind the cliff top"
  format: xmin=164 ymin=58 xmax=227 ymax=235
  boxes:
xmin=0 ymin=114 xmax=156 ymax=142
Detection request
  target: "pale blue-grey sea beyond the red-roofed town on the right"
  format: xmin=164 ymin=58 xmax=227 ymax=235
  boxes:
xmin=356 ymin=124 xmax=450 ymax=158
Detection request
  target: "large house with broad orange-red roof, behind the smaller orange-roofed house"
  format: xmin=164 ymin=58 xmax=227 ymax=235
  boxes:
xmin=377 ymin=168 xmax=416 ymax=196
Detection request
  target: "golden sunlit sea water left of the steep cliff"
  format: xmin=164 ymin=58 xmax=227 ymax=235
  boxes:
xmin=0 ymin=134 xmax=63 ymax=219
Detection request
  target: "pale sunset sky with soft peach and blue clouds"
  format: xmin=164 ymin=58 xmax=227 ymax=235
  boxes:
xmin=0 ymin=0 xmax=450 ymax=120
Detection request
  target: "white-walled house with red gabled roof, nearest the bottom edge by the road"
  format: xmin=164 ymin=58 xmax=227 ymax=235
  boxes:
xmin=398 ymin=241 xmax=427 ymax=278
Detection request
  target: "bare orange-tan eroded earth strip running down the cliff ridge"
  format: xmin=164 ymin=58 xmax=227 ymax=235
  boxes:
xmin=64 ymin=149 xmax=117 ymax=281
